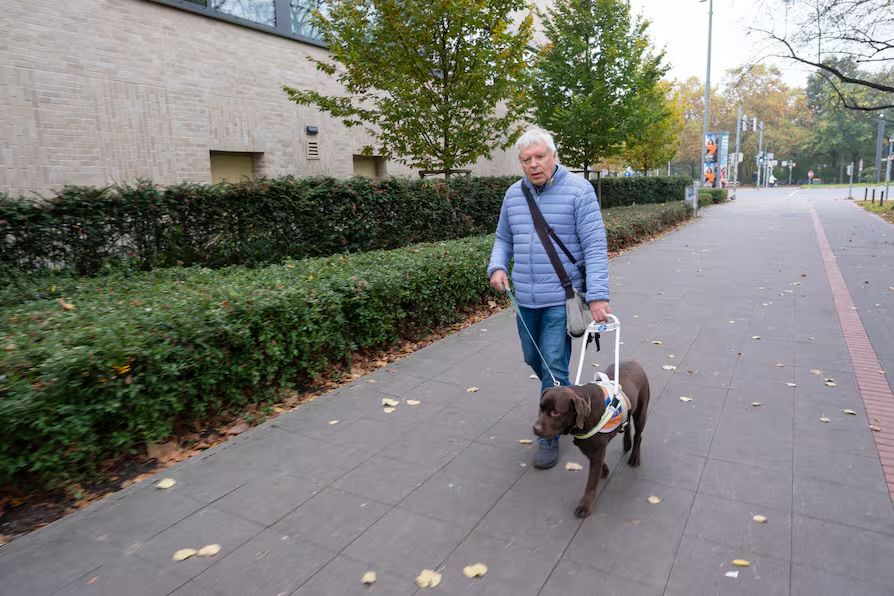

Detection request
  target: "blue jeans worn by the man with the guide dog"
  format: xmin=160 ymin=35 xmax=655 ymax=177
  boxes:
xmin=515 ymin=304 xmax=571 ymax=392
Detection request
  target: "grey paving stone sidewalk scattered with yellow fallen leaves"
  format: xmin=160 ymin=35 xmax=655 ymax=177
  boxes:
xmin=0 ymin=189 xmax=894 ymax=596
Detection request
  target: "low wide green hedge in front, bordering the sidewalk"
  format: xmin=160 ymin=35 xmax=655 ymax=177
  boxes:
xmin=0 ymin=202 xmax=688 ymax=488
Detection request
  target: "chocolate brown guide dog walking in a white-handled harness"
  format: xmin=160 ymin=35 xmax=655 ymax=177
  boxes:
xmin=534 ymin=360 xmax=649 ymax=518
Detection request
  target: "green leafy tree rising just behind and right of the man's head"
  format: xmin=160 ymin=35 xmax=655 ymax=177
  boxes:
xmin=532 ymin=0 xmax=667 ymax=175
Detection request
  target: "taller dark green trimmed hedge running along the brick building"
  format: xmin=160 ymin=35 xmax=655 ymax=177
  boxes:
xmin=0 ymin=176 xmax=686 ymax=276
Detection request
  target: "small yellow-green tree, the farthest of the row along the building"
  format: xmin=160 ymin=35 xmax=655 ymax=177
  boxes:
xmin=621 ymin=81 xmax=683 ymax=173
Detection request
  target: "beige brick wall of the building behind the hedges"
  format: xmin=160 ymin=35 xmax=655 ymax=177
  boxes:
xmin=0 ymin=0 xmax=518 ymax=195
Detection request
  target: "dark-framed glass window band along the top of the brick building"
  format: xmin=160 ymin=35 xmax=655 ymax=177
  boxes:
xmin=147 ymin=0 xmax=326 ymax=46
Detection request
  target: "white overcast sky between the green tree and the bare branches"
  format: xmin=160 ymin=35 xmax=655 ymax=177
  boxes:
xmin=630 ymin=0 xmax=808 ymax=87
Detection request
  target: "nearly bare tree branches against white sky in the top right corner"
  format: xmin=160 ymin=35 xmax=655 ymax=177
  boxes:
xmin=752 ymin=0 xmax=894 ymax=111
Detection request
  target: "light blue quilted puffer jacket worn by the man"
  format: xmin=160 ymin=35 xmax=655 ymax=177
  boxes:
xmin=487 ymin=166 xmax=609 ymax=308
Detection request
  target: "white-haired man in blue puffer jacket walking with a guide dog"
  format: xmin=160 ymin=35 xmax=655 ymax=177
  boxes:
xmin=487 ymin=128 xmax=611 ymax=468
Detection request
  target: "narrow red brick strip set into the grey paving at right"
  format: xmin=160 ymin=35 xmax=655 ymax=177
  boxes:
xmin=810 ymin=206 xmax=894 ymax=499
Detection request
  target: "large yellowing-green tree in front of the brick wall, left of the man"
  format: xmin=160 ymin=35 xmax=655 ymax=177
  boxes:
xmin=283 ymin=0 xmax=532 ymax=176
